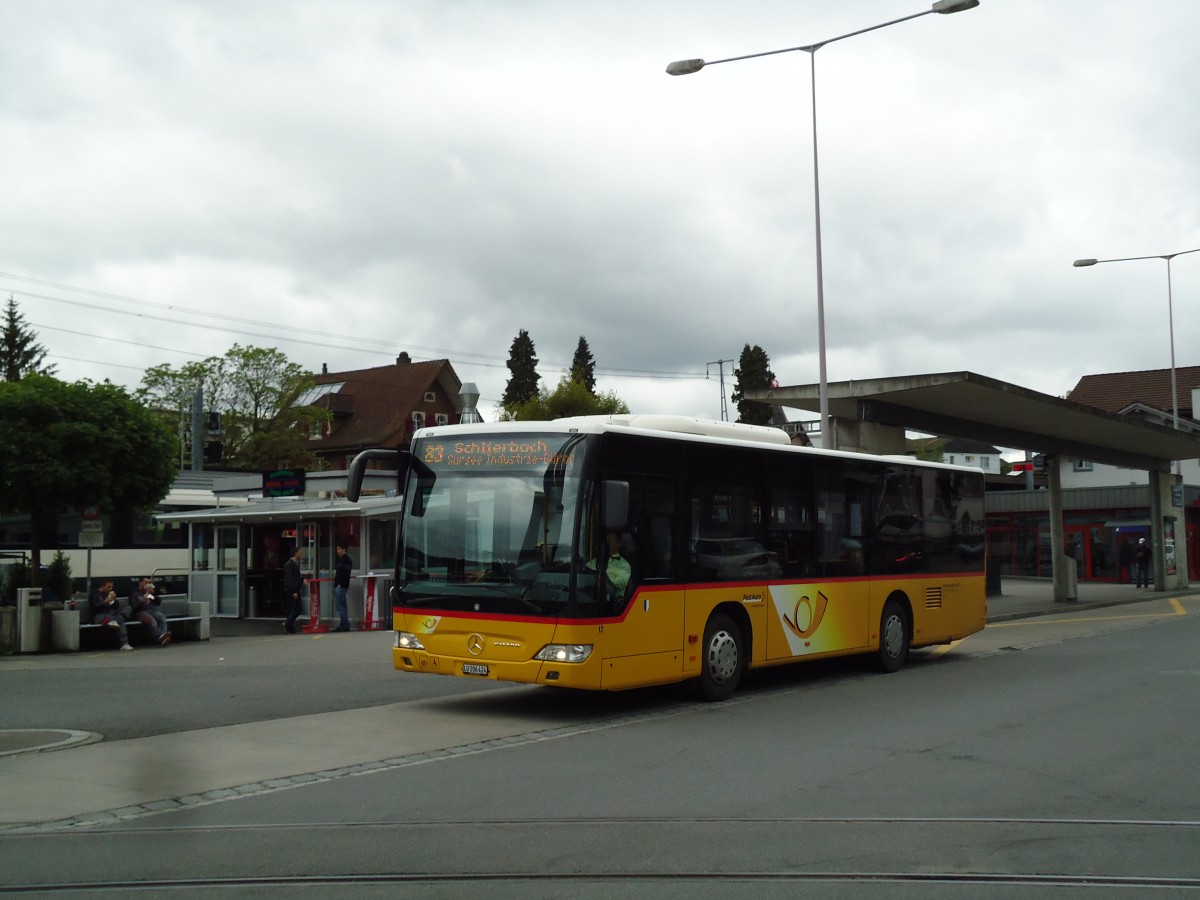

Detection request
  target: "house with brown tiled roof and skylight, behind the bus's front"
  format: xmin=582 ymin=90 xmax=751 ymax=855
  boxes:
xmin=296 ymin=353 xmax=462 ymax=469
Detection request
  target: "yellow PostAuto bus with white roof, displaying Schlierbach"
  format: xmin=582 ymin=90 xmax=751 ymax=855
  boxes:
xmin=349 ymin=415 xmax=986 ymax=700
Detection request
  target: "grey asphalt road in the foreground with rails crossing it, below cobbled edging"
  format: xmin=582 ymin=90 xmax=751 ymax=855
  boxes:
xmin=0 ymin=600 xmax=1200 ymax=898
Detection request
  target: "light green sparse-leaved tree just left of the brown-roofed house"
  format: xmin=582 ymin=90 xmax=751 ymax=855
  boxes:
xmin=142 ymin=344 xmax=329 ymax=470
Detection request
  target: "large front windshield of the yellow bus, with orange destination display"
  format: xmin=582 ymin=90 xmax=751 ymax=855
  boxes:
xmin=397 ymin=433 xmax=594 ymax=617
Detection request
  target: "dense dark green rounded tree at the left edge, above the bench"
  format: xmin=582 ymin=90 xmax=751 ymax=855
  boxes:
xmin=0 ymin=374 xmax=175 ymax=578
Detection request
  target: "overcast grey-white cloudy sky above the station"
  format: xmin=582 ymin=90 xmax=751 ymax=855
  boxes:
xmin=0 ymin=0 xmax=1200 ymax=429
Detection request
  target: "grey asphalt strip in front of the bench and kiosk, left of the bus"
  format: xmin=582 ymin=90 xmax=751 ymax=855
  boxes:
xmin=0 ymin=631 xmax=511 ymax=740
